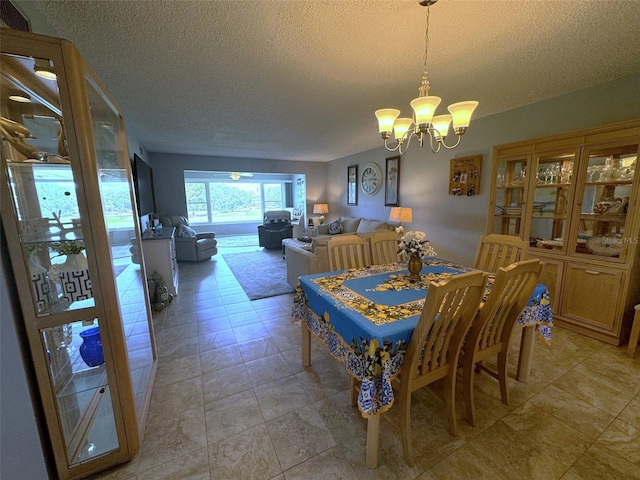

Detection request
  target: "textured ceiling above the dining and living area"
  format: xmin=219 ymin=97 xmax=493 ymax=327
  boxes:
xmin=16 ymin=0 xmax=640 ymax=161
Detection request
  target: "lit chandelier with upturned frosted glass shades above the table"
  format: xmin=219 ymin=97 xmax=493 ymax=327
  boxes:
xmin=376 ymin=0 xmax=478 ymax=154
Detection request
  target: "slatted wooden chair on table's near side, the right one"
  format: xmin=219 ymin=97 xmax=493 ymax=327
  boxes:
xmin=461 ymin=259 xmax=544 ymax=426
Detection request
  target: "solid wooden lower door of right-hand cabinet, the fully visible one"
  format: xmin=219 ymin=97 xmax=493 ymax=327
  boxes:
xmin=560 ymin=264 xmax=626 ymax=332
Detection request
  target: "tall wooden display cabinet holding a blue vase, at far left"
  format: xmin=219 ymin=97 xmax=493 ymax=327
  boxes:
xmin=0 ymin=29 xmax=156 ymax=479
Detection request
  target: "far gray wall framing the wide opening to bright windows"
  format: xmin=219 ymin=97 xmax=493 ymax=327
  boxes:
xmin=148 ymin=153 xmax=327 ymax=235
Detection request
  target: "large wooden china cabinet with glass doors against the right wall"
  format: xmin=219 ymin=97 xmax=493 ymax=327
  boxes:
xmin=487 ymin=120 xmax=640 ymax=345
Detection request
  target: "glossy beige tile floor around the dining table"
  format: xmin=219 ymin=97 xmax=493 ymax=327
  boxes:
xmin=94 ymin=240 xmax=640 ymax=480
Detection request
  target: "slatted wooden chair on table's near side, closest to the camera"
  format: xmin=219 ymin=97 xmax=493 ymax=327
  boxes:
xmin=376 ymin=271 xmax=486 ymax=467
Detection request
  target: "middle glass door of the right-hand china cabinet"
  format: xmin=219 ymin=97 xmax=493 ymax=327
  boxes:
xmin=529 ymin=151 xmax=577 ymax=252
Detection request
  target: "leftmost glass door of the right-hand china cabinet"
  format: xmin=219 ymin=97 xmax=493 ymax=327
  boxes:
xmin=492 ymin=156 xmax=530 ymax=236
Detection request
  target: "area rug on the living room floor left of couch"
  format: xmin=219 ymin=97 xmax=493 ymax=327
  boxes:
xmin=222 ymin=249 xmax=293 ymax=300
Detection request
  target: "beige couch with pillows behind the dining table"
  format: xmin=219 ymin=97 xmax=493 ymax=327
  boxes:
xmin=285 ymin=217 xmax=394 ymax=288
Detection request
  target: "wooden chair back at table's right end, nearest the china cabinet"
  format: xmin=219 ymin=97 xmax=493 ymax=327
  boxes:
xmin=473 ymin=233 xmax=529 ymax=273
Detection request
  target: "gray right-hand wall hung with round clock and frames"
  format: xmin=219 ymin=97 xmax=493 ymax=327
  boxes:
xmin=326 ymin=75 xmax=640 ymax=263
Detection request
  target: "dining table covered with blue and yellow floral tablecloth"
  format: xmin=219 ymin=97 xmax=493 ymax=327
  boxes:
xmin=292 ymin=257 xmax=553 ymax=468
